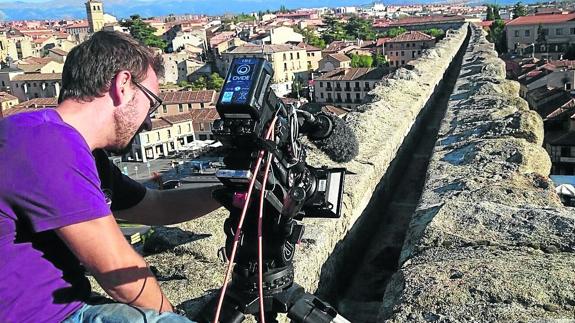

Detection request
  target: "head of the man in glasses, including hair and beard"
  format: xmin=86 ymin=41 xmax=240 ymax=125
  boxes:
xmin=59 ymin=31 xmax=163 ymax=152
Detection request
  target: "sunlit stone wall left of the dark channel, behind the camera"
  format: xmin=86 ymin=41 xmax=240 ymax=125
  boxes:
xmin=136 ymin=25 xmax=467 ymax=317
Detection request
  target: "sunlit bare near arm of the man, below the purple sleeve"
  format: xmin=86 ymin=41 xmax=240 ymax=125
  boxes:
xmin=55 ymin=215 xmax=173 ymax=312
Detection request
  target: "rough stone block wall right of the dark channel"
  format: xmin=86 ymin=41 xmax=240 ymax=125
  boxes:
xmin=379 ymin=26 xmax=575 ymax=322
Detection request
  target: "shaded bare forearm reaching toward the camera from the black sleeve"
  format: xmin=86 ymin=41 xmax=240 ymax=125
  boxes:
xmin=114 ymin=186 xmax=221 ymax=225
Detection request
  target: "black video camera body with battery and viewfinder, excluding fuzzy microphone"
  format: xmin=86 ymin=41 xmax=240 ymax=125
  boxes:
xmin=212 ymin=57 xmax=345 ymax=219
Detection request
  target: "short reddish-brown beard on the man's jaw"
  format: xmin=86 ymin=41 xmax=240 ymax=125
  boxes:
xmin=107 ymin=96 xmax=149 ymax=155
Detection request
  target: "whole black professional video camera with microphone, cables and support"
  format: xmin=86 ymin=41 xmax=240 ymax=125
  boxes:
xmin=197 ymin=58 xmax=358 ymax=323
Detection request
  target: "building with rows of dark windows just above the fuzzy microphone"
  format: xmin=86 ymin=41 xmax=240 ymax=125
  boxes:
xmin=313 ymin=67 xmax=388 ymax=109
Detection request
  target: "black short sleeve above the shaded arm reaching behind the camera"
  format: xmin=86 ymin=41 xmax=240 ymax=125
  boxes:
xmin=94 ymin=150 xmax=146 ymax=211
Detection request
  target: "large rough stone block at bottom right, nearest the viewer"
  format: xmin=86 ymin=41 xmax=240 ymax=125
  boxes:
xmin=378 ymin=246 xmax=575 ymax=322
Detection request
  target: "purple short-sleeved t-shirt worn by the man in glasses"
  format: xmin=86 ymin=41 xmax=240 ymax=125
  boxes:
xmin=0 ymin=109 xmax=111 ymax=322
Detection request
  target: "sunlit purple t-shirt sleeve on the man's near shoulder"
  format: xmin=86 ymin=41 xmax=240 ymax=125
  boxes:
xmin=15 ymin=125 xmax=111 ymax=232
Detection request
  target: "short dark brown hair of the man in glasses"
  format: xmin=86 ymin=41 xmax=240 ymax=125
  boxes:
xmin=58 ymin=31 xmax=164 ymax=102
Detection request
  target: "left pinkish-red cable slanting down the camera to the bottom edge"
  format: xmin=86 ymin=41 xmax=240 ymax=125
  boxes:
xmin=214 ymin=119 xmax=277 ymax=323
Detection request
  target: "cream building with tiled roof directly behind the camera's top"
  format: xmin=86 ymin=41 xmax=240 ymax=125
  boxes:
xmin=222 ymin=44 xmax=309 ymax=96
